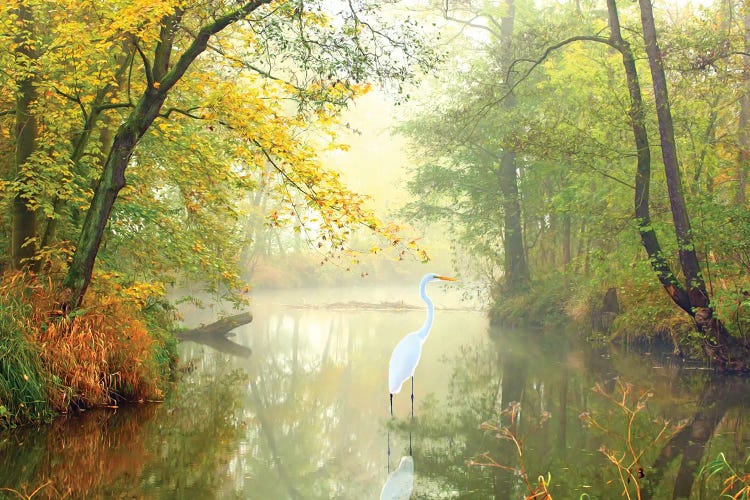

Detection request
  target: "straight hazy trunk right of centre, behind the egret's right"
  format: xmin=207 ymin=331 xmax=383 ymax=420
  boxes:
xmin=498 ymin=0 xmax=529 ymax=294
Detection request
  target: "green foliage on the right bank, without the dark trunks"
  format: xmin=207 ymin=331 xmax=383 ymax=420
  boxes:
xmin=403 ymin=3 xmax=750 ymax=364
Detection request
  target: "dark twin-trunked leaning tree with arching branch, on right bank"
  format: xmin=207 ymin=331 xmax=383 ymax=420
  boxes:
xmin=516 ymin=0 xmax=748 ymax=370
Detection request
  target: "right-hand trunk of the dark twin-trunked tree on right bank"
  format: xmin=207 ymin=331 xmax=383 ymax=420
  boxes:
xmin=638 ymin=0 xmax=750 ymax=370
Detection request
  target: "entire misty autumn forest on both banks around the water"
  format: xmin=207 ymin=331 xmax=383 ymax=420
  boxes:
xmin=0 ymin=0 xmax=750 ymax=492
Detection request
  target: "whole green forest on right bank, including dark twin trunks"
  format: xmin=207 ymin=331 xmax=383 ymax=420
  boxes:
xmin=400 ymin=1 xmax=750 ymax=371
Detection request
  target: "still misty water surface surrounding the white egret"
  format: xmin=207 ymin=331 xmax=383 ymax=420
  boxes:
xmin=0 ymin=285 xmax=750 ymax=499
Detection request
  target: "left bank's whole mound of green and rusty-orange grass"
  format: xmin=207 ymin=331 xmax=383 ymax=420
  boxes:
xmin=0 ymin=273 xmax=176 ymax=428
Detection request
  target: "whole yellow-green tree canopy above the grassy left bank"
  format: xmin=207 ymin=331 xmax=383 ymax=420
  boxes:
xmin=0 ymin=0 xmax=435 ymax=307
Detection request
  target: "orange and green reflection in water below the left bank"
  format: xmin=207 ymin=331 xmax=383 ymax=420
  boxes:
xmin=0 ymin=358 xmax=247 ymax=498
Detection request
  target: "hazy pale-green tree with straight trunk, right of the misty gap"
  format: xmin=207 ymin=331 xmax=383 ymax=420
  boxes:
xmin=404 ymin=1 xmax=544 ymax=296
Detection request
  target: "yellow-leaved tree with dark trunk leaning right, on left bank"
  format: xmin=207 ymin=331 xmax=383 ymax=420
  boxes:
xmin=2 ymin=0 xmax=433 ymax=308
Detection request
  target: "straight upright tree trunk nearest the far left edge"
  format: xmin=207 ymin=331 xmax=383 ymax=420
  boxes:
xmin=10 ymin=0 xmax=37 ymax=269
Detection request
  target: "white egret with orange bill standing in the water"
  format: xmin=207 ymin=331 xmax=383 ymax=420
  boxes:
xmin=388 ymin=273 xmax=456 ymax=417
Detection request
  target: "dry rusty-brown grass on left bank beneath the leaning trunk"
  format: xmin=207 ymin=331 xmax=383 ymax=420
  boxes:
xmin=0 ymin=273 xmax=161 ymax=411
